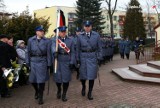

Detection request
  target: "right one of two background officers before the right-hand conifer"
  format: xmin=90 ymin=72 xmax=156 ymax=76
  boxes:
xmin=124 ymin=37 xmax=132 ymax=59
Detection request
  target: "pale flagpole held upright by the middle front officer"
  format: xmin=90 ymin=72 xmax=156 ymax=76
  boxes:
xmin=54 ymin=8 xmax=60 ymax=73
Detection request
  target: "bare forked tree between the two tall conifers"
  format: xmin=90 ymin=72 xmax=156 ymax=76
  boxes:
xmin=105 ymin=0 xmax=118 ymax=36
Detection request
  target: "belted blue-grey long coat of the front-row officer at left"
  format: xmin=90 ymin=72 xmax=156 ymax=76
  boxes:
xmin=26 ymin=36 xmax=51 ymax=83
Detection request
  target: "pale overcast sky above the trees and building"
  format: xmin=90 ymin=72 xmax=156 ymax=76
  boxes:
xmin=3 ymin=0 xmax=158 ymax=14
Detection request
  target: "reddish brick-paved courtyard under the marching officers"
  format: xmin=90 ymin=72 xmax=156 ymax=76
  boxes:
xmin=0 ymin=53 xmax=160 ymax=108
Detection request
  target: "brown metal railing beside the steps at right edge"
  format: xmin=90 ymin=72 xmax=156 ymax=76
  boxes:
xmin=136 ymin=40 xmax=160 ymax=64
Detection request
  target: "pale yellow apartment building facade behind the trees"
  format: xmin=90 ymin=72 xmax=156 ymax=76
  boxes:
xmin=34 ymin=6 xmax=158 ymax=38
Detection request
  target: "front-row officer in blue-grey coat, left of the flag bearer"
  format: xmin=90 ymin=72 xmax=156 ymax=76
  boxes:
xmin=26 ymin=26 xmax=51 ymax=105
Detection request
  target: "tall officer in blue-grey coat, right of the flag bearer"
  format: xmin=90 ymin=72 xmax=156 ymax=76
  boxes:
xmin=77 ymin=21 xmax=102 ymax=100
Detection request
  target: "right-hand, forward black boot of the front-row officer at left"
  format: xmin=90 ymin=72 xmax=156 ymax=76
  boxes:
xmin=38 ymin=83 xmax=45 ymax=105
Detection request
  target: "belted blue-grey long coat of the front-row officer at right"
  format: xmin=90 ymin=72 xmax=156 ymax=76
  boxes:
xmin=77 ymin=31 xmax=102 ymax=80
